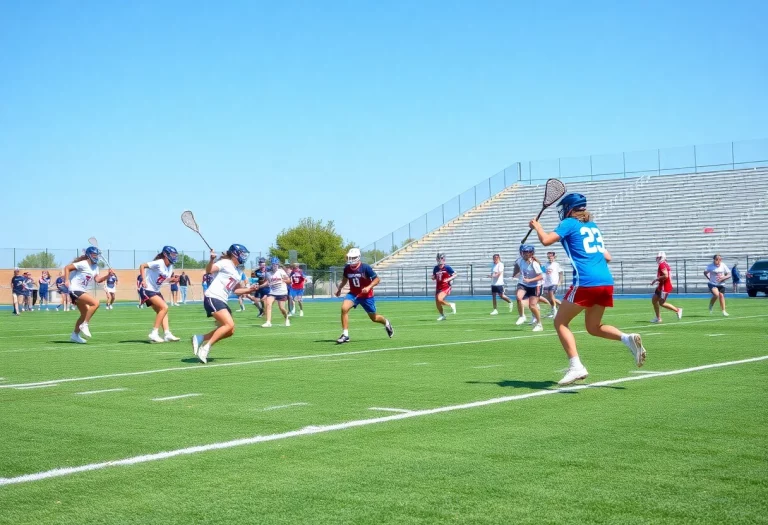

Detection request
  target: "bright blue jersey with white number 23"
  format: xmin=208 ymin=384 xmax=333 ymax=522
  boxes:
xmin=555 ymin=217 xmax=613 ymax=286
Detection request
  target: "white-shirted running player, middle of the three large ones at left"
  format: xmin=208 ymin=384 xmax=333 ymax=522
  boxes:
xmin=139 ymin=246 xmax=179 ymax=343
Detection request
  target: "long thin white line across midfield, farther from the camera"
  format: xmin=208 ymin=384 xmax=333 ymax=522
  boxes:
xmin=0 ymin=314 xmax=768 ymax=389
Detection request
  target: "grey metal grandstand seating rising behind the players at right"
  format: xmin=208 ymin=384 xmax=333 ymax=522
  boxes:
xmin=368 ymin=168 xmax=768 ymax=295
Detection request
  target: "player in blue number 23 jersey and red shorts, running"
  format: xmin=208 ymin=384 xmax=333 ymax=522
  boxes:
xmin=529 ymin=193 xmax=645 ymax=386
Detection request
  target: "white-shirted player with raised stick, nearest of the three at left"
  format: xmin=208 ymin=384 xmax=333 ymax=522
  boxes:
xmin=192 ymin=244 xmax=256 ymax=363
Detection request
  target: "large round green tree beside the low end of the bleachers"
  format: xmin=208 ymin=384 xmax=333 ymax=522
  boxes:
xmin=269 ymin=217 xmax=352 ymax=270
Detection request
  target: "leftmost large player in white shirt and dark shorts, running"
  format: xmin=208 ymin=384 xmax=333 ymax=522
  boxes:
xmin=64 ymin=246 xmax=107 ymax=344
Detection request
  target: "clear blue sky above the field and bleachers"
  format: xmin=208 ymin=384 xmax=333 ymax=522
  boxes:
xmin=0 ymin=0 xmax=768 ymax=251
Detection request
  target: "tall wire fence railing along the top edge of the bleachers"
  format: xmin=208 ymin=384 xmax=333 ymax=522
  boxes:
xmin=361 ymin=139 xmax=768 ymax=264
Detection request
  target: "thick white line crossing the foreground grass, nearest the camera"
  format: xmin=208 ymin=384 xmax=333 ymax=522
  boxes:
xmin=0 ymin=355 xmax=768 ymax=486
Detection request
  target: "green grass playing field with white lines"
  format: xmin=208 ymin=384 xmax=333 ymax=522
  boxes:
xmin=0 ymin=299 xmax=768 ymax=524
